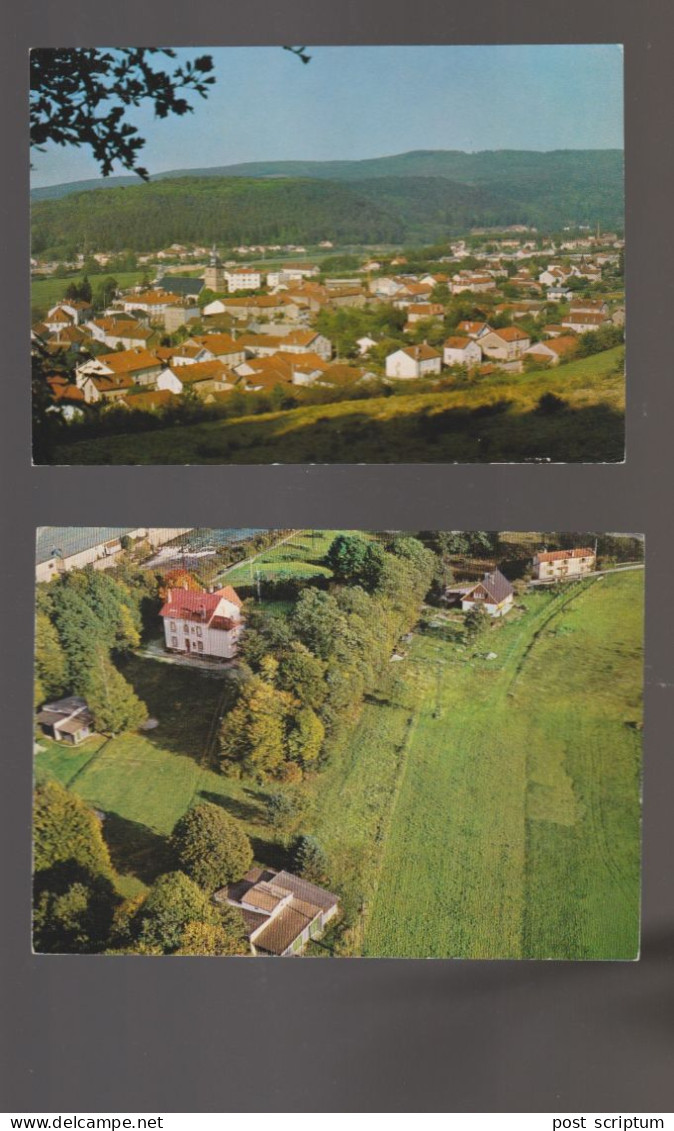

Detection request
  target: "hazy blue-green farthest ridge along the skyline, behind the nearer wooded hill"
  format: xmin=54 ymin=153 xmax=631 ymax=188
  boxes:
xmin=31 ymin=149 xmax=623 ymax=200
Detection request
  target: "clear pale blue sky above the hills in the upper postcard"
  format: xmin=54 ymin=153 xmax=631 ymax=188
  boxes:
xmin=32 ymin=44 xmax=623 ymax=187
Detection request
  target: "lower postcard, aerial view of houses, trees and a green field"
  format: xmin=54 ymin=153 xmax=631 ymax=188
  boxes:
xmin=33 ymin=527 xmax=643 ymax=959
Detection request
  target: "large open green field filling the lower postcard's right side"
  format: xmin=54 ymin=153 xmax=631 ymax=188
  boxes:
xmin=363 ymin=573 xmax=643 ymax=959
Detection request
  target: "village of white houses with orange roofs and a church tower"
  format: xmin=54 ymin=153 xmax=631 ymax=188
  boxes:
xmin=32 ymin=227 xmax=624 ymax=426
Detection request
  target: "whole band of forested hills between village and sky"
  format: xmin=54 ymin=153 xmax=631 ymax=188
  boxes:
xmin=33 ymin=149 xmax=623 ymax=253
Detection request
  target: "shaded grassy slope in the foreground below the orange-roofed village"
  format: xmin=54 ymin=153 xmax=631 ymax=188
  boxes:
xmin=54 ymin=347 xmax=624 ymax=464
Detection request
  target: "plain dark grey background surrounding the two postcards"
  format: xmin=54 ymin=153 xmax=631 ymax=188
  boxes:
xmin=0 ymin=0 xmax=674 ymax=1113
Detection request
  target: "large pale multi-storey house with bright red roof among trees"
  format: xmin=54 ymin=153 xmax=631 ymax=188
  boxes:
xmin=159 ymin=585 xmax=243 ymax=659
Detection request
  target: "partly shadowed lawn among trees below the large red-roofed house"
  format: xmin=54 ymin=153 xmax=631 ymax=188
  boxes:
xmin=35 ymin=657 xmax=273 ymax=896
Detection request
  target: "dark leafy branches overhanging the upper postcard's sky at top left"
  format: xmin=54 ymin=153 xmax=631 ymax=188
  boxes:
xmin=31 ymin=48 xmax=215 ymax=180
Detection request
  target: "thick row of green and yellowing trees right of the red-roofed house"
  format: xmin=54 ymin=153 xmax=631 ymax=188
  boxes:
xmin=219 ymin=535 xmax=435 ymax=783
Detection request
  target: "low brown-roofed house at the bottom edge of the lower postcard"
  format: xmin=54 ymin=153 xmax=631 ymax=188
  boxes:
xmin=214 ymin=867 xmax=339 ymax=957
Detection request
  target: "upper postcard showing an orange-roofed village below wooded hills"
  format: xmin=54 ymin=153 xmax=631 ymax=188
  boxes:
xmin=31 ymin=44 xmax=625 ymax=465
